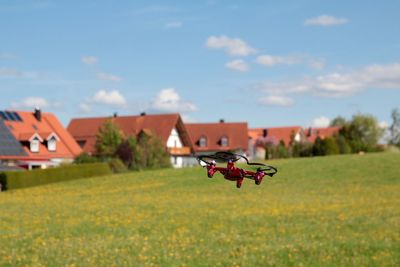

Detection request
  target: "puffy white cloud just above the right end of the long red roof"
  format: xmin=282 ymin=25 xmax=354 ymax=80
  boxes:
xmin=152 ymin=88 xmax=197 ymax=112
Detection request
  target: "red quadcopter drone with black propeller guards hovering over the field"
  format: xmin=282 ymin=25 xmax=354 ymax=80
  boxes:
xmin=197 ymin=152 xmax=278 ymax=188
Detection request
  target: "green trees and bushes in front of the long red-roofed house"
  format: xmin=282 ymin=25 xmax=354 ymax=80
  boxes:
xmin=75 ymin=120 xmax=171 ymax=172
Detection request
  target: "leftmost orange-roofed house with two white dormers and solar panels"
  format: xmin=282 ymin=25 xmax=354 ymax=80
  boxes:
xmin=0 ymin=108 xmax=82 ymax=169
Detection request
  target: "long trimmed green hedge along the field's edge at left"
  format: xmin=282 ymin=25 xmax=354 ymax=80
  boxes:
xmin=0 ymin=163 xmax=112 ymax=190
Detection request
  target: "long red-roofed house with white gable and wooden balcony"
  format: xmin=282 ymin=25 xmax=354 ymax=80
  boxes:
xmin=67 ymin=113 xmax=192 ymax=168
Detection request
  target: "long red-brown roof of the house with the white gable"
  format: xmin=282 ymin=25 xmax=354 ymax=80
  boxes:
xmin=67 ymin=114 xmax=191 ymax=153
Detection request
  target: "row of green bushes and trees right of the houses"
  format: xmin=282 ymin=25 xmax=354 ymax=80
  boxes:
xmin=265 ymin=114 xmax=384 ymax=159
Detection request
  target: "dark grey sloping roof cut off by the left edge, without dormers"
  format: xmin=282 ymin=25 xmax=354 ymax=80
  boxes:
xmin=0 ymin=119 xmax=27 ymax=157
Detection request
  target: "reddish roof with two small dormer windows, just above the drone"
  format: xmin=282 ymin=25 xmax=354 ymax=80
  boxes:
xmin=186 ymin=122 xmax=248 ymax=152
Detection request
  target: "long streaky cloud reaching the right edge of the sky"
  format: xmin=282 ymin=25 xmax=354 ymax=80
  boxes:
xmin=258 ymin=63 xmax=400 ymax=97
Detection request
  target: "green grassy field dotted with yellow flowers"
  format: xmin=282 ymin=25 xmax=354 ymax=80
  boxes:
xmin=0 ymin=153 xmax=400 ymax=266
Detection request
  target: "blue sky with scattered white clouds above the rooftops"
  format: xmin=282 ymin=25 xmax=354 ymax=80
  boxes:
xmin=0 ymin=0 xmax=400 ymax=127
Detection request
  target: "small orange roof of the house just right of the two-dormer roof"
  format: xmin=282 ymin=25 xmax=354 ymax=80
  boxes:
xmin=248 ymin=126 xmax=302 ymax=145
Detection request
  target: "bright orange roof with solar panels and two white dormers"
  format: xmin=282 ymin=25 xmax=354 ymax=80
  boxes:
xmin=3 ymin=111 xmax=82 ymax=159
